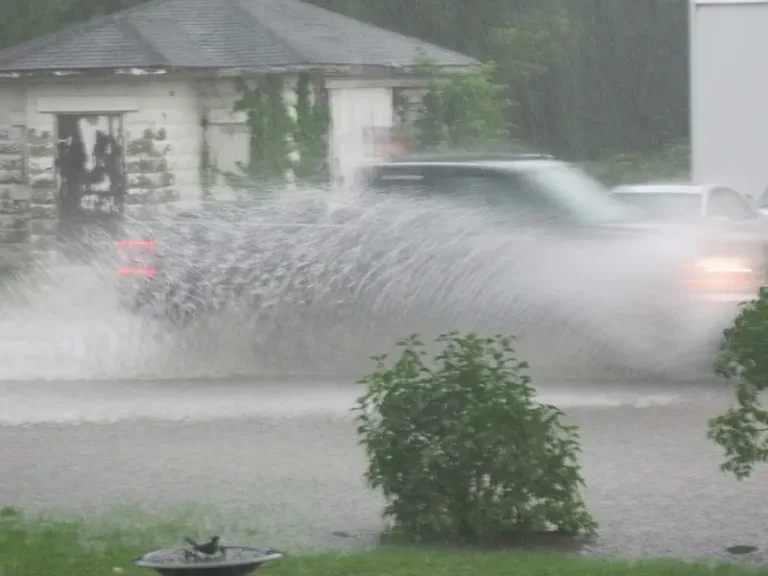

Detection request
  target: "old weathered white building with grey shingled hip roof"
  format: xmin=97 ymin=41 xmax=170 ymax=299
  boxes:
xmin=0 ymin=0 xmax=477 ymax=264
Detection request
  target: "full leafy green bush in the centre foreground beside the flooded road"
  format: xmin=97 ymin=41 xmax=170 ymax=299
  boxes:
xmin=355 ymin=333 xmax=596 ymax=544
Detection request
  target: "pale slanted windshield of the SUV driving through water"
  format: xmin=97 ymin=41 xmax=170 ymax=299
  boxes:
xmin=521 ymin=162 xmax=635 ymax=224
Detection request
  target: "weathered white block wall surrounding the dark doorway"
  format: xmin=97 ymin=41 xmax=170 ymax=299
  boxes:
xmin=0 ymin=77 xmax=208 ymax=267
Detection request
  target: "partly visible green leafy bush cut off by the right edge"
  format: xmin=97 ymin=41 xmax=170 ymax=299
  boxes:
xmin=707 ymin=290 xmax=768 ymax=480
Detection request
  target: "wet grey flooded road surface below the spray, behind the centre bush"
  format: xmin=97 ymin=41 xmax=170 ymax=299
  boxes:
xmin=0 ymin=379 xmax=768 ymax=557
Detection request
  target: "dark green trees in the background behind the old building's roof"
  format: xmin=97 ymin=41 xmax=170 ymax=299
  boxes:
xmin=0 ymin=0 xmax=688 ymax=159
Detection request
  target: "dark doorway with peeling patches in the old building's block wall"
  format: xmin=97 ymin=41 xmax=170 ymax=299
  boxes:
xmin=56 ymin=114 xmax=126 ymax=260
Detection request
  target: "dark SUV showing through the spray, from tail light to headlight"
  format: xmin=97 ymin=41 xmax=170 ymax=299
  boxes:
xmin=114 ymin=154 xmax=757 ymax=321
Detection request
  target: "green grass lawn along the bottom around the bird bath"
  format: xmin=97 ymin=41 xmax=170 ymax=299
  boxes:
xmin=0 ymin=509 xmax=768 ymax=576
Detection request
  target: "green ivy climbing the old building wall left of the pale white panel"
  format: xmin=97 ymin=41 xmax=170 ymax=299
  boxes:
xmin=230 ymin=73 xmax=329 ymax=180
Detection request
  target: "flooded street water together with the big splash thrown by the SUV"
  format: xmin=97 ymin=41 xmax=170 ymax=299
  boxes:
xmin=0 ymin=193 xmax=756 ymax=557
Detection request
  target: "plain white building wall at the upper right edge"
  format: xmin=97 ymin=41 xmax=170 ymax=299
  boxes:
xmin=690 ymin=0 xmax=768 ymax=199
